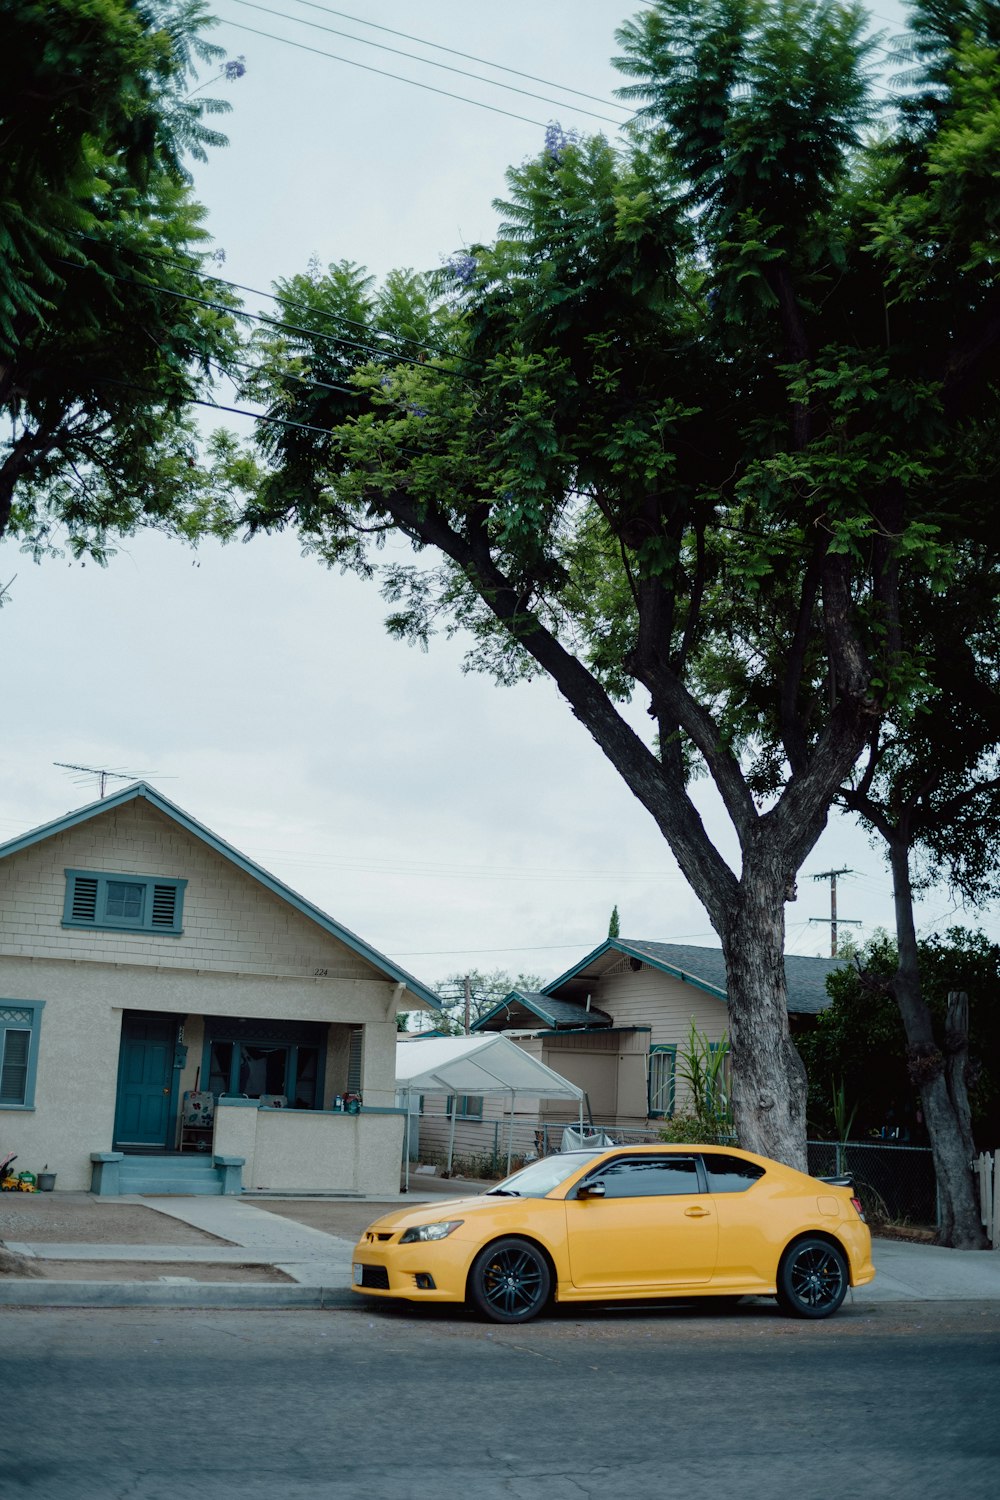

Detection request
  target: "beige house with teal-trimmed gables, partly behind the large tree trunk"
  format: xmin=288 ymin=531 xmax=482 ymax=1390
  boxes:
xmin=420 ymin=938 xmax=841 ymax=1155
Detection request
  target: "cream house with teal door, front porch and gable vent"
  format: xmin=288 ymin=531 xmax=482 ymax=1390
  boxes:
xmin=0 ymin=783 xmax=438 ymax=1193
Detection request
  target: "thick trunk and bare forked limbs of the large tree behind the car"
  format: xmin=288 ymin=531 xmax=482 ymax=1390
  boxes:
xmin=382 ymin=492 xmax=867 ymax=1172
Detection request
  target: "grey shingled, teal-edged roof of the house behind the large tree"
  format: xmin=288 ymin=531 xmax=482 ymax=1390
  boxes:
xmin=546 ymin=938 xmax=847 ymax=1016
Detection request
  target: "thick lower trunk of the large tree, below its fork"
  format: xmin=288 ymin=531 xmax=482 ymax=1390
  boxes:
xmin=721 ymin=870 xmax=808 ymax=1172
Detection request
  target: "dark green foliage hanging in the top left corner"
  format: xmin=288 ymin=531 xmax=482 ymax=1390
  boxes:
xmin=0 ymin=0 xmax=245 ymax=561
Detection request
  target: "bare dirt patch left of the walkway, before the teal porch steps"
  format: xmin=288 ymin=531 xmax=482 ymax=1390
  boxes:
xmin=0 ymin=1193 xmax=231 ymax=1245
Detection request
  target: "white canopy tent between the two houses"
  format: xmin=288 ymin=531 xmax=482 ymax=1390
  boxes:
xmin=396 ymin=1032 xmax=585 ymax=1193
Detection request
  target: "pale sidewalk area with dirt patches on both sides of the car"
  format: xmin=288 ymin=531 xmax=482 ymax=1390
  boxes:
xmin=0 ymin=1181 xmax=1000 ymax=1308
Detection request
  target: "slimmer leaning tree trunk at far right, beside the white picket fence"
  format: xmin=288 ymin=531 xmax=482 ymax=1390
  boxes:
xmin=889 ymin=837 xmax=987 ymax=1250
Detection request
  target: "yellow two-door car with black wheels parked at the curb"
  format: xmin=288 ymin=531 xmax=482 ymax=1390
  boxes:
xmin=354 ymin=1145 xmax=876 ymax=1323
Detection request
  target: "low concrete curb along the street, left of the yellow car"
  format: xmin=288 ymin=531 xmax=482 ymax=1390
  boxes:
xmin=0 ymin=1277 xmax=363 ymax=1311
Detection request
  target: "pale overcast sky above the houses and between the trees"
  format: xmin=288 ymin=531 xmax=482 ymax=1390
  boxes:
xmin=0 ymin=0 xmax=983 ymax=1008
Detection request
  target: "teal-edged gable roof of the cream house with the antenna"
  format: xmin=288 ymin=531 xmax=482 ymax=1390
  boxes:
xmin=0 ymin=782 xmax=441 ymax=1011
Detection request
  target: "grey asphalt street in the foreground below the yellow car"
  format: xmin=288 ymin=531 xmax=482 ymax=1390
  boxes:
xmin=0 ymin=1301 xmax=1000 ymax=1500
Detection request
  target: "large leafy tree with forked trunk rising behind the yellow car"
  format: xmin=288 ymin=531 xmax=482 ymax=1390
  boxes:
xmin=236 ymin=0 xmax=1000 ymax=1161
